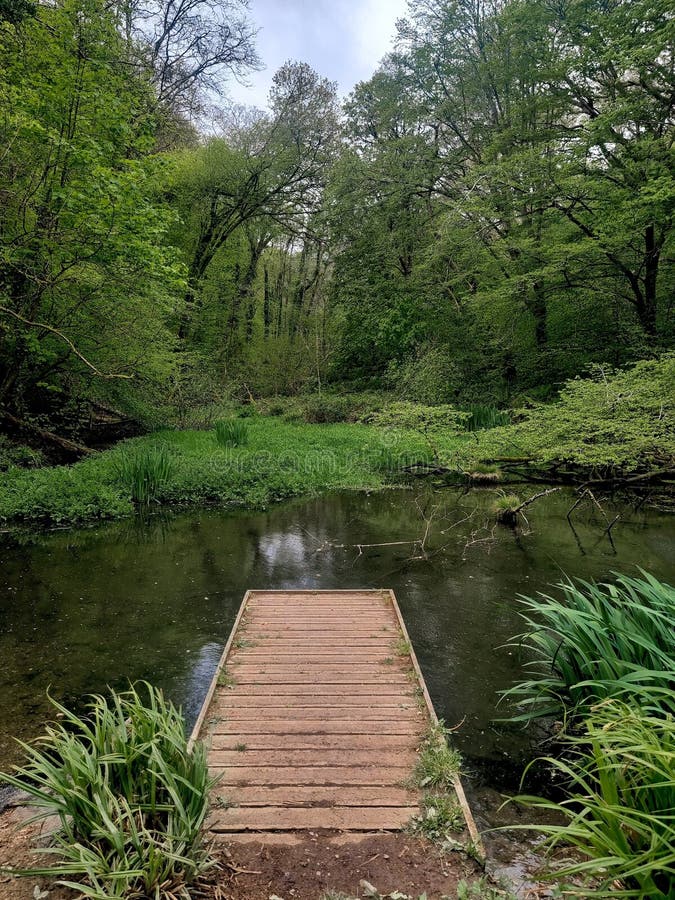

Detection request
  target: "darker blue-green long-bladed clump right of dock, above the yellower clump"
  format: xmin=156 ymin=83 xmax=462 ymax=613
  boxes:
xmin=505 ymin=573 xmax=675 ymax=719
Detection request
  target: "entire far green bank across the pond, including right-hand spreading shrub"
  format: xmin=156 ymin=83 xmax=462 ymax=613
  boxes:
xmin=0 ymin=356 xmax=675 ymax=526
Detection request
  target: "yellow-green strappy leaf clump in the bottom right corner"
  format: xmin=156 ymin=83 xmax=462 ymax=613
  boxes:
xmin=518 ymin=704 xmax=675 ymax=900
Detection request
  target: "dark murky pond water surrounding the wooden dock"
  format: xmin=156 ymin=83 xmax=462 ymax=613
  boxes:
xmin=0 ymin=485 xmax=675 ymax=876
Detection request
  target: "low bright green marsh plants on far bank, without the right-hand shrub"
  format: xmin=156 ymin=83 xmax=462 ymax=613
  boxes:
xmin=0 ymin=417 xmax=471 ymax=524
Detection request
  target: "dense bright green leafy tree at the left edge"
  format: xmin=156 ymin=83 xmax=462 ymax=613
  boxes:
xmin=0 ymin=0 xmax=182 ymax=410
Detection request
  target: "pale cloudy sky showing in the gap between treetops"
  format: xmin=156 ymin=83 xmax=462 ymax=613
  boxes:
xmin=229 ymin=0 xmax=407 ymax=108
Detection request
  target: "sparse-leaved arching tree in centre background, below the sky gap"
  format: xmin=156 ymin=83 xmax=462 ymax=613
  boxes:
xmin=171 ymin=63 xmax=337 ymax=337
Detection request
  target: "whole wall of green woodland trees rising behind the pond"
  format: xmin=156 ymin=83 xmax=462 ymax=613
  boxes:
xmin=0 ymin=0 xmax=675 ymax=427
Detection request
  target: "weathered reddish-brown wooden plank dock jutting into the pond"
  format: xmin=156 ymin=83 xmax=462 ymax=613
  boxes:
xmin=192 ymin=590 xmax=479 ymax=844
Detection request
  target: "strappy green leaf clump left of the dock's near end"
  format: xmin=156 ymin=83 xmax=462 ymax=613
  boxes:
xmin=1 ymin=684 xmax=213 ymax=900
